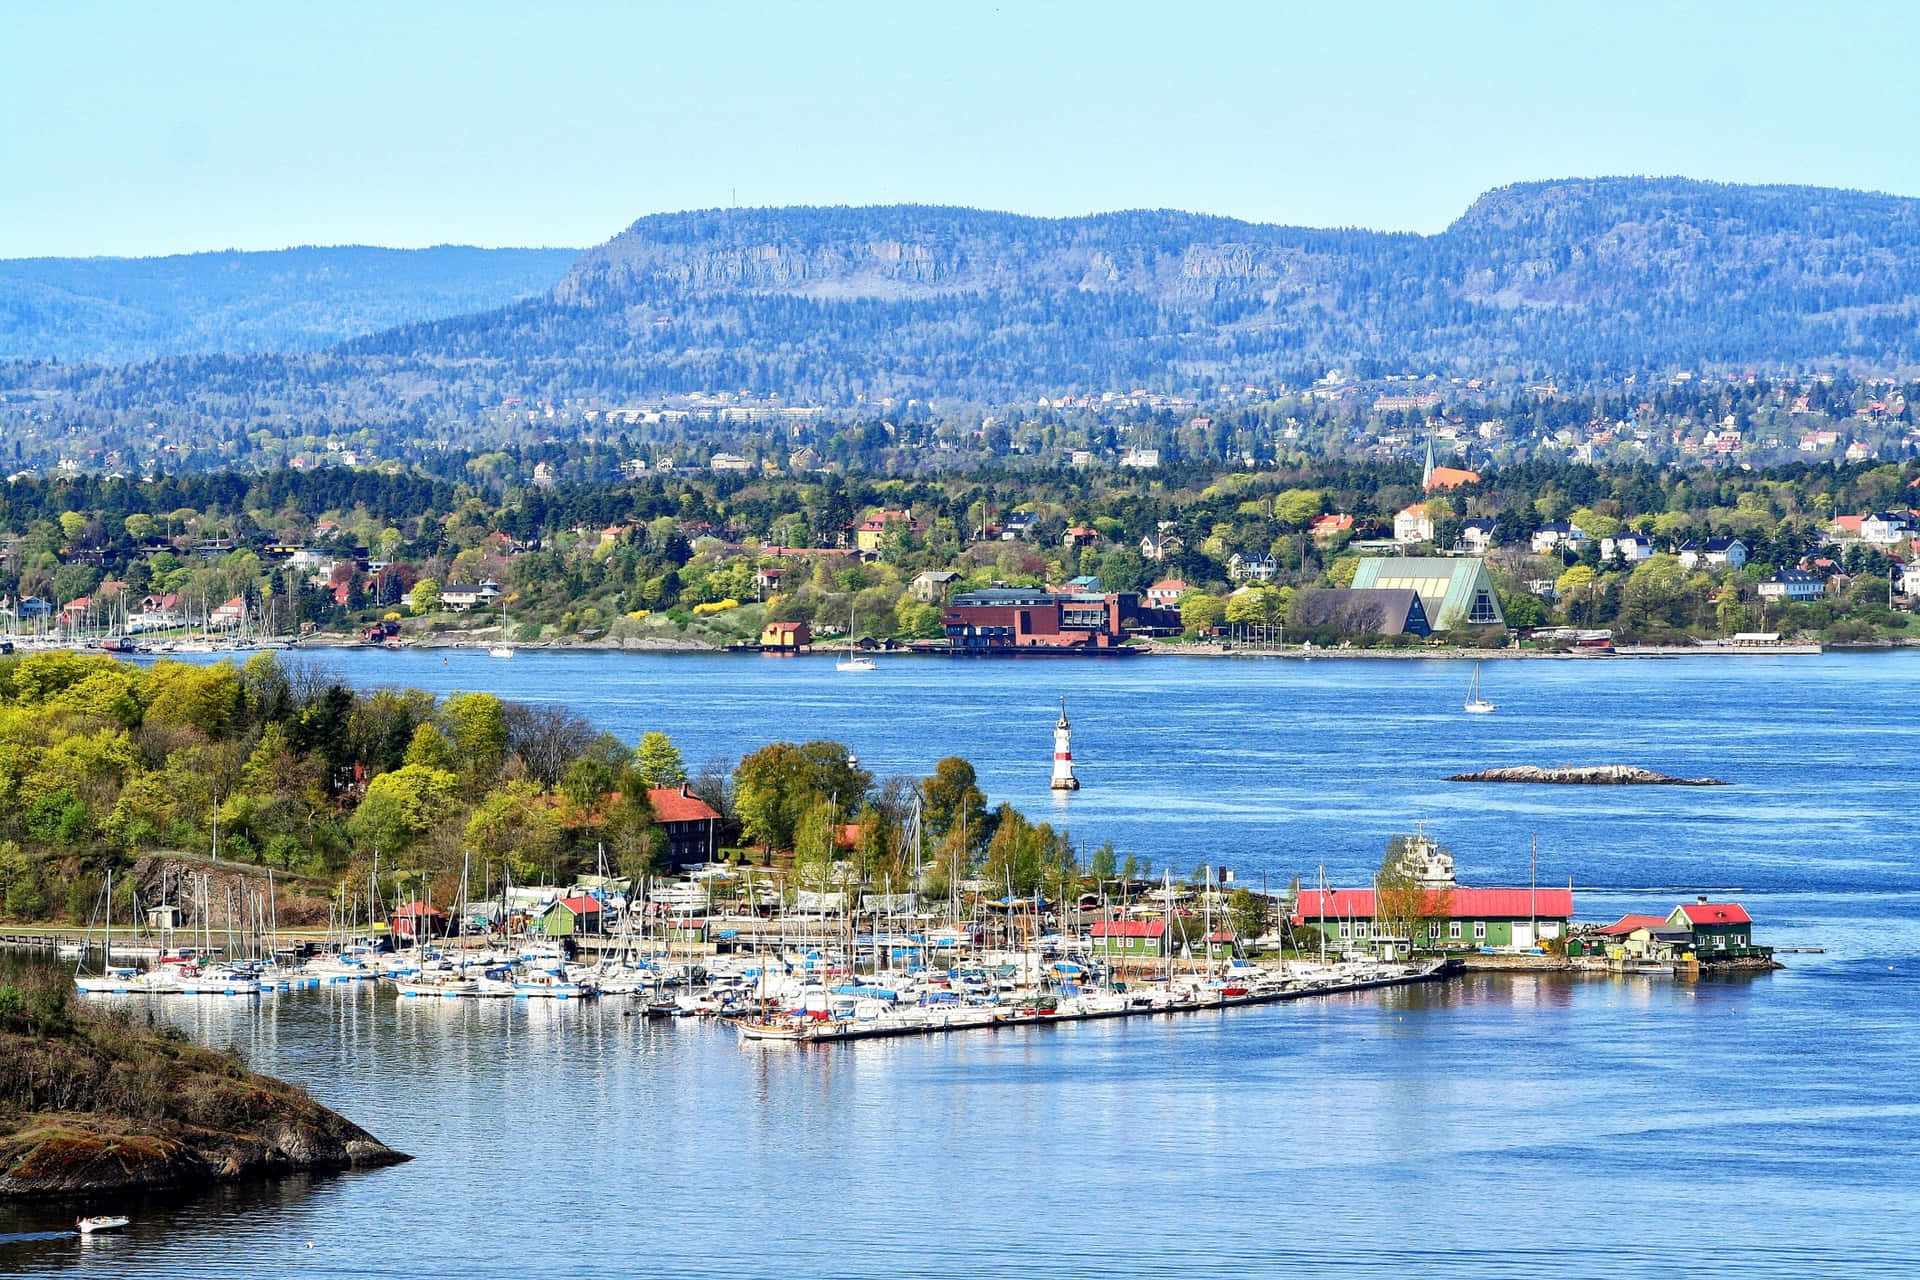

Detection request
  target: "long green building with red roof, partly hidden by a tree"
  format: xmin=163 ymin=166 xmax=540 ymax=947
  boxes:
xmin=1294 ymin=889 xmax=1572 ymax=952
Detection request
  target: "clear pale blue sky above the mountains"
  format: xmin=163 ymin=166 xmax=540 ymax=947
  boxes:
xmin=0 ymin=0 xmax=1920 ymax=257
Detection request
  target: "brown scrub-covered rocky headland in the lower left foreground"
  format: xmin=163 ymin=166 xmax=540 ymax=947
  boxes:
xmin=0 ymin=973 xmax=411 ymax=1199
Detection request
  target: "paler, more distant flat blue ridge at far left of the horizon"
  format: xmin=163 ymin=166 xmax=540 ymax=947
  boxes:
xmin=0 ymin=246 xmax=576 ymax=363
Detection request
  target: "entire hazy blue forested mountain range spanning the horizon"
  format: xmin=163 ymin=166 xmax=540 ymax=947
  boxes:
xmin=11 ymin=178 xmax=1920 ymax=418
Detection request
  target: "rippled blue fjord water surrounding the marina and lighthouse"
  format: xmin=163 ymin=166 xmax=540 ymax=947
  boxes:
xmin=0 ymin=651 xmax=1920 ymax=1278
